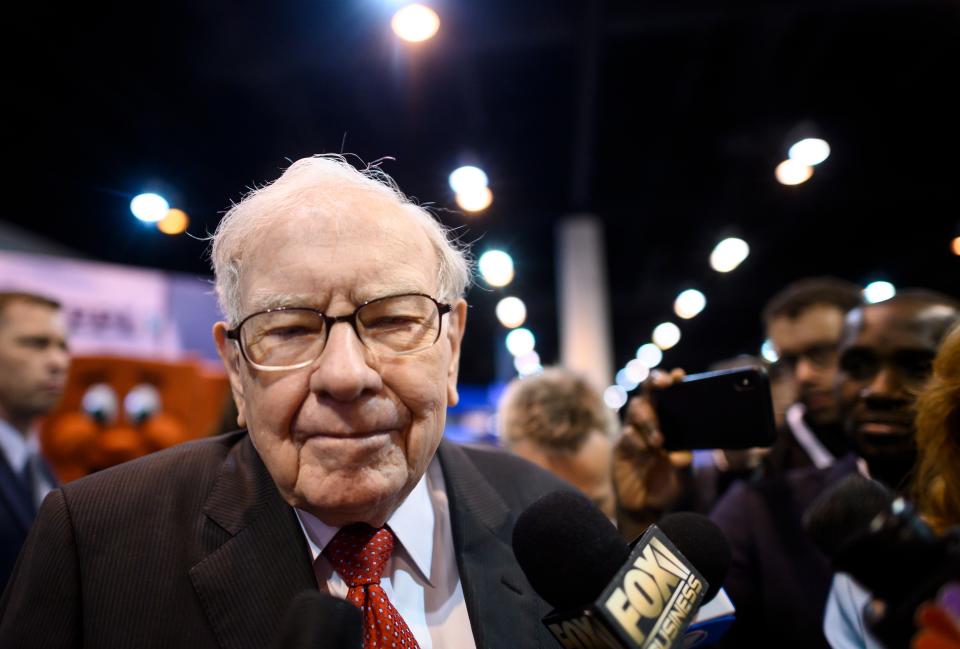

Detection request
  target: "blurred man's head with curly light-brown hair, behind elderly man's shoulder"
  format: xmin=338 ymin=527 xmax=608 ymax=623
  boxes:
xmin=497 ymin=367 xmax=615 ymax=519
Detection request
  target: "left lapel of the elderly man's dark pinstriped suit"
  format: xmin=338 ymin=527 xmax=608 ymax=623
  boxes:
xmin=190 ymin=437 xmax=317 ymax=649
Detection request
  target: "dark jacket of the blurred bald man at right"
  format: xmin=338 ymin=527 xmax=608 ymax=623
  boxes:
xmin=710 ymin=455 xmax=856 ymax=649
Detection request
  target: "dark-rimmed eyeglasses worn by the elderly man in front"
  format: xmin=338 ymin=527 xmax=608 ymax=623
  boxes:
xmin=227 ymin=293 xmax=452 ymax=372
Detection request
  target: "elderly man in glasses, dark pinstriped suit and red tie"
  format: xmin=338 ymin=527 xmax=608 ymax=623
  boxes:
xmin=0 ymin=157 xmax=564 ymax=649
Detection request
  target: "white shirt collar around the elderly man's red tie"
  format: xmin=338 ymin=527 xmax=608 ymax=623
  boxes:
xmin=295 ymin=457 xmax=438 ymax=583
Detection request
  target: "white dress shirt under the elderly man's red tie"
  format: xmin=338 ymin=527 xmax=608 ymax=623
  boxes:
xmin=296 ymin=457 xmax=476 ymax=649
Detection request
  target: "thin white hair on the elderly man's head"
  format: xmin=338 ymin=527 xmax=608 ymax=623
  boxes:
xmin=210 ymin=154 xmax=471 ymax=326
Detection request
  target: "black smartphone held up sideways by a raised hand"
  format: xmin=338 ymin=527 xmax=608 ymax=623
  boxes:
xmin=651 ymin=367 xmax=776 ymax=451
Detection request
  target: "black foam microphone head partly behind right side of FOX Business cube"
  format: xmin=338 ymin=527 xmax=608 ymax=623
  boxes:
xmin=657 ymin=512 xmax=733 ymax=602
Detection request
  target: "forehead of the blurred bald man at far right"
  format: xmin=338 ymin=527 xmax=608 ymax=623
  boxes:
xmin=841 ymin=302 xmax=955 ymax=351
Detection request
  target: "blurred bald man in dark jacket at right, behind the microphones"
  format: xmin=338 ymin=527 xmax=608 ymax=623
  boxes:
xmin=711 ymin=290 xmax=960 ymax=649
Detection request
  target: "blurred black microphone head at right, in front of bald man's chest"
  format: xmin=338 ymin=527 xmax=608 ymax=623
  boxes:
xmin=803 ymin=473 xmax=893 ymax=559
